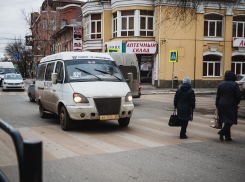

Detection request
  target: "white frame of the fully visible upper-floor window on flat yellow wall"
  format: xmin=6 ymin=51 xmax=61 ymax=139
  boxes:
xmin=203 ymin=12 xmax=224 ymax=38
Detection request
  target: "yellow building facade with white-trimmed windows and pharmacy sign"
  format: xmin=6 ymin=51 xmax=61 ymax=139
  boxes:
xmin=82 ymin=0 xmax=245 ymax=88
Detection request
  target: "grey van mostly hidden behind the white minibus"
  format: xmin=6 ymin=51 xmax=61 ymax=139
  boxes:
xmin=109 ymin=52 xmax=141 ymax=98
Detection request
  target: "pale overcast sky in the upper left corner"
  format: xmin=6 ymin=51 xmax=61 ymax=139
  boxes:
xmin=0 ymin=0 xmax=86 ymax=58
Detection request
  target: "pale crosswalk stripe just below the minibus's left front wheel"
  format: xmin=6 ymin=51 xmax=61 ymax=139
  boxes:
xmin=50 ymin=125 xmax=125 ymax=153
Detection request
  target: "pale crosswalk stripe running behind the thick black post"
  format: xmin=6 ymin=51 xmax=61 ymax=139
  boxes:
xmin=19 ymin=128 xmax=79 ymax=159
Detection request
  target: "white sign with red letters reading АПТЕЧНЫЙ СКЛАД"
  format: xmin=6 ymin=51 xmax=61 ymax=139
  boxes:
xmin=126 ymin=41 xmax=157 ymax=54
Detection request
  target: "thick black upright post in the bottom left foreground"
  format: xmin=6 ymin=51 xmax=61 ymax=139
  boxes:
xmin=24 ymin=139 xmax=42 ymax=182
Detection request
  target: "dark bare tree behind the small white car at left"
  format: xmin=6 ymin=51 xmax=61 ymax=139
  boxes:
xmin=5 ymin=38 xmax=33 ymax=77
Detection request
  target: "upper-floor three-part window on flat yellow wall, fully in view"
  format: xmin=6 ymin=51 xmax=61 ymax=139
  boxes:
xmin=204 ymin=14 xmax=223 ymax=37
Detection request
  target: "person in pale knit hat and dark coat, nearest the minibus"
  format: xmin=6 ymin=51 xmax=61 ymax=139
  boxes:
xmin=174 ymin=77 xmax=196 ymax=139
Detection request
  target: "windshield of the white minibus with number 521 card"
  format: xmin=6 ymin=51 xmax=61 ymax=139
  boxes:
xmin=66 ymin=59 xmax=125 ymax=82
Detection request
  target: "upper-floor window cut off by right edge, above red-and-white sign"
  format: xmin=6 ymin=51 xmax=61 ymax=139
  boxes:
xmin=232 ymin=16 xmax=245 ymax=37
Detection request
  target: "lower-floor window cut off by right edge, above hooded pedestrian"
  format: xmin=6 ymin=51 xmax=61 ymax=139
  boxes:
xmin=231 ymin=56 xmax=245 ymax=75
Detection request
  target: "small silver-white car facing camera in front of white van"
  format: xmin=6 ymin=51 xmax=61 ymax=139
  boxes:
xmin=2 ymin=73 xmax=25 ymax=91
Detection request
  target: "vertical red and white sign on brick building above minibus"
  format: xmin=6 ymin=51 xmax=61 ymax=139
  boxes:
xmin=73 ymin=27 xmax=83 ymax=52
